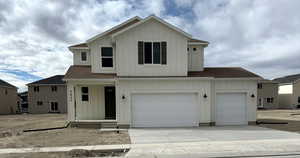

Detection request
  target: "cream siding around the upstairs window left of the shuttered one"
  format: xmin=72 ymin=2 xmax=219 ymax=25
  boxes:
xmin=89 ymin=35 xmax=116 ymax=73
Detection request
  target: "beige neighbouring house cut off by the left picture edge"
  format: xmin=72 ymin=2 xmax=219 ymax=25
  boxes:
xmin=0 ymin=79 xmax=18 ymax=115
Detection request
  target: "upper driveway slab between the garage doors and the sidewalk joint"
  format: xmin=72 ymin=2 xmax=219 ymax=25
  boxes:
xmin=129 ymin=126 xmax=300 ymax=144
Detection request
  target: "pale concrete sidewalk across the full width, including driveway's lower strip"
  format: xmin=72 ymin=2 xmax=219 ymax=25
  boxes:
xmin=0 ymin=139 xmax=300 ymax=158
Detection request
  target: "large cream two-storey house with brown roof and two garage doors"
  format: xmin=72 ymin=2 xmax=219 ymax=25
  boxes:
xmin=64 ymin=16 xmax=261 ymax=127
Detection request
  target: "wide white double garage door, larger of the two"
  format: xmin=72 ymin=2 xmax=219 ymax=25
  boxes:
xmin=131 ymin=93 xmax=200 ymax=127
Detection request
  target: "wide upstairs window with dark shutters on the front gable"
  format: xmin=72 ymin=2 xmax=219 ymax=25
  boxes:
xmin=138 ymin=41 xmax=167 ymax=65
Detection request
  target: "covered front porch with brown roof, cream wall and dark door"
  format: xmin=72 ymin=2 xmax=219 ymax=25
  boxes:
xmin=64 ymin=66 xmax=117 ymax=127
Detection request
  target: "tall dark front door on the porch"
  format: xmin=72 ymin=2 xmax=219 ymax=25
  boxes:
xmin=104 ymin=87 xmax=116 ymax=119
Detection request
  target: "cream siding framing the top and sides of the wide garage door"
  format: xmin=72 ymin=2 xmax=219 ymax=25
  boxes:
xmin=116 ymin=79 xmax=211 ymax=125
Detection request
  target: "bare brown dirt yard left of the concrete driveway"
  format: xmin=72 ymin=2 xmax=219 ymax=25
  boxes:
xmin=0 ymin=114 xmax=130 ymax=148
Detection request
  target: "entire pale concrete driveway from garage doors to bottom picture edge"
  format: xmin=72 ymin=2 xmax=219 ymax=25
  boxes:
xmin=127 ymin=126 xmax=300 ymax=158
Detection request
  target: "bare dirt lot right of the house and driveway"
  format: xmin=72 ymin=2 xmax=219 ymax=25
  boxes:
xmin=257 ymin=110 xmax=300 ymax=133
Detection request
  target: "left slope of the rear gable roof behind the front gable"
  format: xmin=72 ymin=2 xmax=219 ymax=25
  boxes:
xmin=86 ymin=16 xmax=142 ymax=43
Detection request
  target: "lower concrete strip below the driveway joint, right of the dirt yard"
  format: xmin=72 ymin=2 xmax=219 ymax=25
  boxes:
xmin=126 ymin=139 xmax=300 ymax=158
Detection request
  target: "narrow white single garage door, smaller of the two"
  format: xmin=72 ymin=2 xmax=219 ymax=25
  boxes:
xmin=216 ymin=93 xmax=247 ymax=125
